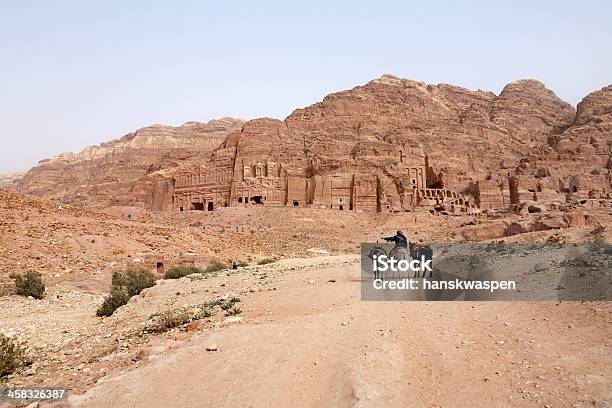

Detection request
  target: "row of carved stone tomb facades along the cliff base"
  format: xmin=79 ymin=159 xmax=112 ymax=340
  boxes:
xmin=174 ymin=154 xmax=476 ymax=212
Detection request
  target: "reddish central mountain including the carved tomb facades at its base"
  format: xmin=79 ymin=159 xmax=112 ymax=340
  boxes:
xmin=174 ymin=75 xmax=611 ymax=213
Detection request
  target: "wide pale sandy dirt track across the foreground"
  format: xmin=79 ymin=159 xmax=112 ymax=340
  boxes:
xmin=64 ymin=256 xmax=612 ymax=407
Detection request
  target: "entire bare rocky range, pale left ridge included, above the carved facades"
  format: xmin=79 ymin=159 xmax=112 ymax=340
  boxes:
xmin=15 ymin=75 xmax=612 ymax=210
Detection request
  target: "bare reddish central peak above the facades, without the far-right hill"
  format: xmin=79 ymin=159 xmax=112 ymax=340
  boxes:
xmin=227 ymin=75 xmax=575 ymax=190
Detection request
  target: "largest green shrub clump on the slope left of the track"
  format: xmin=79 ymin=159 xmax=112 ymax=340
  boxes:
xmin=96 ymin=269 xmax=155 ymax=316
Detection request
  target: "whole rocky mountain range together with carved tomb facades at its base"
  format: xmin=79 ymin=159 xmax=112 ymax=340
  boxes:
xmin=16 ymin=75 xmax=612 ymax=213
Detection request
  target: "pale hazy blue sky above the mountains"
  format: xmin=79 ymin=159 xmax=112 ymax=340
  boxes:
xmin=0 ymin=0 xmax=612 ymax=173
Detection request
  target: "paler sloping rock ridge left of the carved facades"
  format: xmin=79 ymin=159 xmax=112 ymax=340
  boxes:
xmin=17 ymin=118 xmax=243 ymax=210
